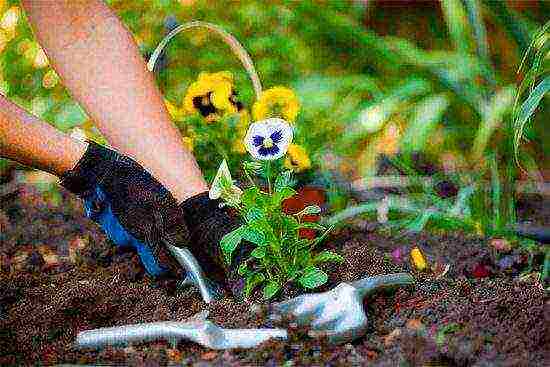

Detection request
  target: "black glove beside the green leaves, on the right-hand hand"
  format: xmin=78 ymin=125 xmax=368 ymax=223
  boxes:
xmin=180 ymin=192 xmax=253 ymax=297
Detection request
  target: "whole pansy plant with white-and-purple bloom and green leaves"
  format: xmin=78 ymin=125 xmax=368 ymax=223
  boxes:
xmin=210 ymin=118 xmax=343 ymax=299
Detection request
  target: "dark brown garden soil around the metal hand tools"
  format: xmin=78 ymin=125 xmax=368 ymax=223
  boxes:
xmin=0 ymin=185 xmax=550 ymax=366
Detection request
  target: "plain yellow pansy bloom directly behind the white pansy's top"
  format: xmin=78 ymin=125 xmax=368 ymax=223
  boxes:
xmin=252 ymin=86 xmax=300 ymax=122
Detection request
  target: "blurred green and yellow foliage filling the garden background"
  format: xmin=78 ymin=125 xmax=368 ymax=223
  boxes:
xmin=0 ymin=0 xmax=550 ymax=236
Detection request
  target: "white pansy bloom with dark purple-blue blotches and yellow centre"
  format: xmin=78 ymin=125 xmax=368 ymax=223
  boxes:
xmin=244 ymin=118 xmax=293 ymax=160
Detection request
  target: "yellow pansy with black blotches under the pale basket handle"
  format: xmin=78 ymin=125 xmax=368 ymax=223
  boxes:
xmin=183 ymin=71 xmax=242 ymax=122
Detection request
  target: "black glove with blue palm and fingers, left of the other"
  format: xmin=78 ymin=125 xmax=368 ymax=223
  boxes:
xmin=61 ymin=142 xmax=189 ymax=277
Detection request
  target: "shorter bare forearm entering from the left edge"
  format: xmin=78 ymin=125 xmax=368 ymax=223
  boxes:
xmin=0 ymin=95 xmax=87 ymax=176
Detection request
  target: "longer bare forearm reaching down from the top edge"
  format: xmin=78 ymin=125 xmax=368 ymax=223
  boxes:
xmin=22 ymin=0 xmax=207 ymax=200
